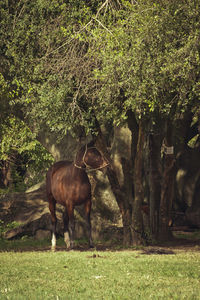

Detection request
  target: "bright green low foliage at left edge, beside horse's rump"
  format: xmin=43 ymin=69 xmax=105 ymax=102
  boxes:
xmin=0 ymin=64 xmax=52 ymax=191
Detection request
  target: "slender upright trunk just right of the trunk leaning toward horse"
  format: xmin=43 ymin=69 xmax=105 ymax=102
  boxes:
xmin=132 ymin=121 xmax=145 ymax=245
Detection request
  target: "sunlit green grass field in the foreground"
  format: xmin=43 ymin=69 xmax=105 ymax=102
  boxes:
xmin=0 ymin=238 xmax=200 ymax=300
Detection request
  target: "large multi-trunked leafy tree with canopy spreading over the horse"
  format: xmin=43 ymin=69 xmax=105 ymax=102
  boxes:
xmin=2 ymin=0 xmax=200 ymax=244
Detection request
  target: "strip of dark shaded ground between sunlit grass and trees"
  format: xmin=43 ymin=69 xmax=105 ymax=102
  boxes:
xmin=0 ymin=232 xmax=200 ymax=255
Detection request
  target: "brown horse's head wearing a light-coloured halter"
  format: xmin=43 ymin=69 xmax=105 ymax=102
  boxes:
xmin=75 ymin=145 xmax=109 ymax=170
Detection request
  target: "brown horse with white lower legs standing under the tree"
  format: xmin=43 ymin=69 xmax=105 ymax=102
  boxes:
xmin=46 ymin=143 xmax=108 ymax=251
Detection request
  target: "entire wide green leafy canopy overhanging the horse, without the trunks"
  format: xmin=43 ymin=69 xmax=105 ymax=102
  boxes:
xmin=2 ymin=0 xmax=200 ymax=137
